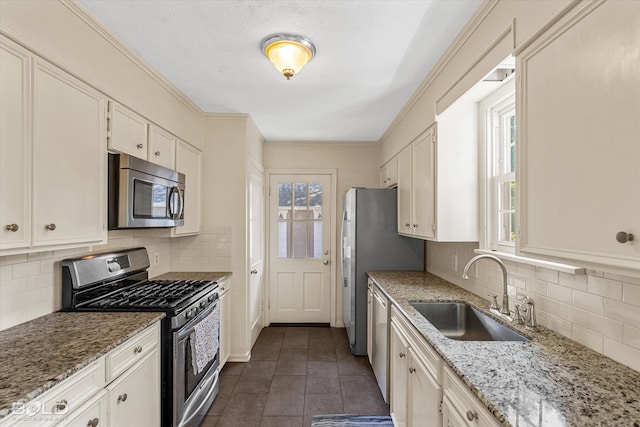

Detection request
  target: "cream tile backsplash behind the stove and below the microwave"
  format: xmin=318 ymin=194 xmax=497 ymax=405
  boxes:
xmin=0 ymin=227 xmax=231 ymax=330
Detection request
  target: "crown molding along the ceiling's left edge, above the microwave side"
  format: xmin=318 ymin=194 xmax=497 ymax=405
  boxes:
xmin=58 ymin=0 xmax=204 ymax=117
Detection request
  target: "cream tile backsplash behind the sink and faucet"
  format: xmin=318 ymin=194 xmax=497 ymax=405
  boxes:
xmin=427 ymin=242 xmax=640 ymax=371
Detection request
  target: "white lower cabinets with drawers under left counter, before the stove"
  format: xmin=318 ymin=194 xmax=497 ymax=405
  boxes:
xmin=0 ymin=322 xmax=161 ymax=427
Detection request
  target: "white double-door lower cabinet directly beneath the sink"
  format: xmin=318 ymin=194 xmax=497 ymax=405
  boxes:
xmin=389 ymin=307 xmax=442 ymax=427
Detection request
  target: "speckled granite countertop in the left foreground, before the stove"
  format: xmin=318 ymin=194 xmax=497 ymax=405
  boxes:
xmin=0 ymin=312 xmax=164 ymax=418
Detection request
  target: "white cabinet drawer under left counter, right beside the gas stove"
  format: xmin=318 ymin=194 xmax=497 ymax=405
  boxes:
xmin=106 ymin=323 xmax=160 ymax=383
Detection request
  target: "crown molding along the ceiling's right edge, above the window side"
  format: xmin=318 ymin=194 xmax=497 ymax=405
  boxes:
xmin=379 ymin=0 xmax=500 ymax=143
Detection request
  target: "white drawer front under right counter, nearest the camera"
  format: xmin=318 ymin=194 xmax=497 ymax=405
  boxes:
xmin=443 ymin=368 xmax=499 ymax=427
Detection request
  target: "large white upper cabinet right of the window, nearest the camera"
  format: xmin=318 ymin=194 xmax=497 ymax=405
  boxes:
xmin=516 ymin=1 xmax=640 ymax=271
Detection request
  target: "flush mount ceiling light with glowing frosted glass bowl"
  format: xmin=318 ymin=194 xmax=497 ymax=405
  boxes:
xmin=260 ymin=33 xmax=316 ymax=80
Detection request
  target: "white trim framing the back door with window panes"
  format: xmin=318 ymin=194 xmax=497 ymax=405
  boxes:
xmin=262 ymin=169 xmax=339 ymax=327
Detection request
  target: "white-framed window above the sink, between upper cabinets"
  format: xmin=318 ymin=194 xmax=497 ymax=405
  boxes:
xmin=479 ymin=78 xmax=517 ymax=253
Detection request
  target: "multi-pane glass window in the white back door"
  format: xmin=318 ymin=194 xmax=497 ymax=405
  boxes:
xmin=278 ymin=182 xmax=322 ymax=258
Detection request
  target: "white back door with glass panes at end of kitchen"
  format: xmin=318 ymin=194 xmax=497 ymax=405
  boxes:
xmin=269 ymin=175 xmax=333 ymax=323
